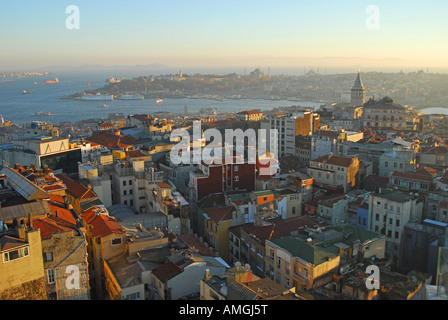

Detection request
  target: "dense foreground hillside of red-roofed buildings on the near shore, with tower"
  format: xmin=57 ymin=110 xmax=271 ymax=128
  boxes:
xmin=0 ymin=73 xmax=448 ymax=301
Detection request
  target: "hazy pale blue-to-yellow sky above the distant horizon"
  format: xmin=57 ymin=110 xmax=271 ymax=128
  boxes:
xmin=0 ymin=0 xmax=448 ymax=71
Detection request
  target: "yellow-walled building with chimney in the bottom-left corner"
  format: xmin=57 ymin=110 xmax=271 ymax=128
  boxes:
xmin=0 ymin=227 xmax=47 ymax=300
